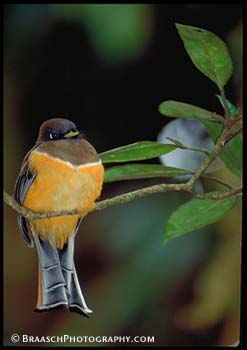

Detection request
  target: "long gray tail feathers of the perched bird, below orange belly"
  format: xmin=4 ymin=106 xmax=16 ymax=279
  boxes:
xmin=31 ymin=234 xmax=92 ymax=317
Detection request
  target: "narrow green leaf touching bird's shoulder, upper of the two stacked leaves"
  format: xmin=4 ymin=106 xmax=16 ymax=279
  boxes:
xmin=99 ymin=141 xmax=177 ymax=163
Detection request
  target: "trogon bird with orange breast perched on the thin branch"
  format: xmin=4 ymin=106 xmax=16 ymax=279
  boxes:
xmin=14 ymin=118 xmax=104 ymax=317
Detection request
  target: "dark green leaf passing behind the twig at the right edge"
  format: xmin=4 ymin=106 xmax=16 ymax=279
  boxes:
xmin=201 ymin=120 xmax=243 ymax=177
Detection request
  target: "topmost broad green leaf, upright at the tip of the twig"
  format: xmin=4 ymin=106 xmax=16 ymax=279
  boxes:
xmin=176 ymin=23 xmax=233 ymax=88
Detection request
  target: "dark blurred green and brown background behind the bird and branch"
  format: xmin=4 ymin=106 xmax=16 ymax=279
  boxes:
xmin=4 ymin=3 xmax=242 ymax=346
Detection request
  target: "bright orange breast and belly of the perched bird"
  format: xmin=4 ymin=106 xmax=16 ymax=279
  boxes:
xmin=24 ymin=151 xmax=104 ymax=248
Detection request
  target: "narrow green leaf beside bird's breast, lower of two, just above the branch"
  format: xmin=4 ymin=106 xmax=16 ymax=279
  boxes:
xmin=104 ymin=164 xmax=193 ymax=182
